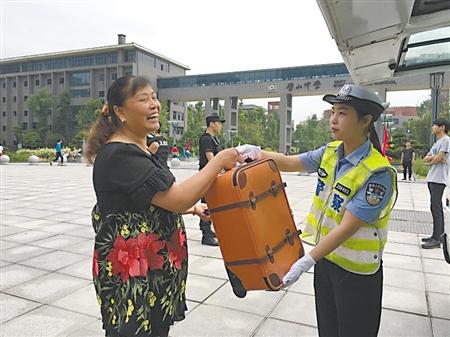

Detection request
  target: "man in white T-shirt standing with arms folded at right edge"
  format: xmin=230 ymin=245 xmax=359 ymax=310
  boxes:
xmin=422 ymin=118 xmax=450 ymax=249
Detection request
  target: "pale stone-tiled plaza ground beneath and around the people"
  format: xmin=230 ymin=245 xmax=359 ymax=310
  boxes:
xmin=0 ymin=162 xmax=450 ymax=337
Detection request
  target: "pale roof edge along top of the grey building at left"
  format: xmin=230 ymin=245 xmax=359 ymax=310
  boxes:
xmin=0 ymin=42 xmax=191 ymax=70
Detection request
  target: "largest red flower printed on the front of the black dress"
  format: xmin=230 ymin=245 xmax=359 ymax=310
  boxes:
xmin=106 ymin=233 xmax=164 ymax=282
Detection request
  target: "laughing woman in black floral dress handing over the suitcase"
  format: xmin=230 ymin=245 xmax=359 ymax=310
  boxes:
xmin=86 ymin=76 xmax=239 ymax=336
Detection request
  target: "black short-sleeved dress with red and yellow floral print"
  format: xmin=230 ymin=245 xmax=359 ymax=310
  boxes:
xmin=92 ymin=143 xmax=187 ymax=336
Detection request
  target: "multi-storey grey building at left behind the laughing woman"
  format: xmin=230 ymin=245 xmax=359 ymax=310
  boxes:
xmin=0 ymin=34 xmax=189 ymax=147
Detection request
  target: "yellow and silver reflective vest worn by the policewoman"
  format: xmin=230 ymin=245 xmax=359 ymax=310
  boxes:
xmin=302 ymin=141 xmax=397 ymax=275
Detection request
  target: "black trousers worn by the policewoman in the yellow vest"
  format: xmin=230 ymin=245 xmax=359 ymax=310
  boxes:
xmin=314 ymin=259 xmax=383 ymax=337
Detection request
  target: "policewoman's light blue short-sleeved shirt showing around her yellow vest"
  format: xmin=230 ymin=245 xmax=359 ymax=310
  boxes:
xmin=300 ymin=140 xmax=393 ymax=223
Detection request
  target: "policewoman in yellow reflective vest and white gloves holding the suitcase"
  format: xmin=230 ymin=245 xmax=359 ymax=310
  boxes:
xmin=238 ymin=84 xmax=397 ymax=337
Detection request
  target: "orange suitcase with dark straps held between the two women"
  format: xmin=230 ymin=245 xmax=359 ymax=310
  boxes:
xmin=205 ymin=159 xmax=304 ymax=297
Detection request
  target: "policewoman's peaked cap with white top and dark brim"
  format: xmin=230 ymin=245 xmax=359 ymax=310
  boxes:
xmin=322 ymin=84 xmax=387 ymax=121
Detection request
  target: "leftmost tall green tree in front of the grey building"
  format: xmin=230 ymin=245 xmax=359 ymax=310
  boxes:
xmin=24 ymin=88 xmax=54 ymax=144
